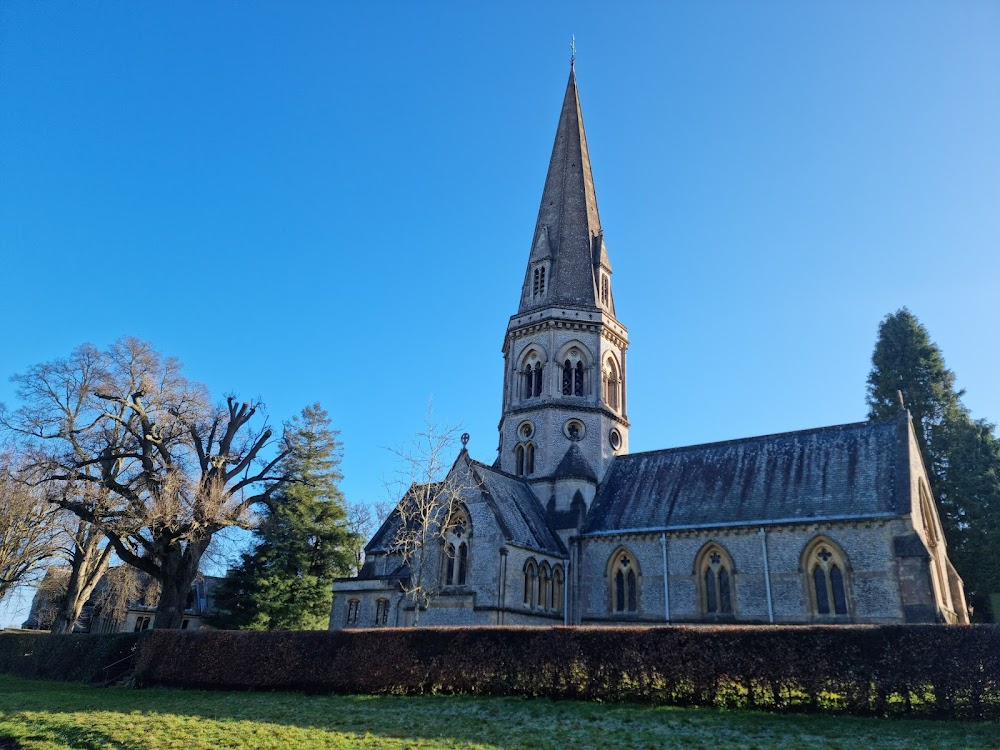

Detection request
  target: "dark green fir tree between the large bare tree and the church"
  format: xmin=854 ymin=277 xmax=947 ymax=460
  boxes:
xmin=212 ymin=403 xmax=354 ymax=630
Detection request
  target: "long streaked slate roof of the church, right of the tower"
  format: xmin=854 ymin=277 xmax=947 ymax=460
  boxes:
xmin=585 ymin=418 xmax=909 ymax=533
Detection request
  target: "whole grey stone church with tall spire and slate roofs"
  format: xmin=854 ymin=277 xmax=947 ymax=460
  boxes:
xmin=330 ymin=65 xmax=968 ymax=629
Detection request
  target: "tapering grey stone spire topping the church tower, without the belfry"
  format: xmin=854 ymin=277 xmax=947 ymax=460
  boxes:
xmin=518 ymin=66 xmax=614 ymax=314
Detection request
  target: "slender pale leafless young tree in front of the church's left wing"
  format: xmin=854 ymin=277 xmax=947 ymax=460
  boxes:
xmin=390 ymin=420 xmax=472 ymax=626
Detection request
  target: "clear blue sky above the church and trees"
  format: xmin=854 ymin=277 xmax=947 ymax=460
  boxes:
xmin=0 ymin=0 xmax=1000 ymax=624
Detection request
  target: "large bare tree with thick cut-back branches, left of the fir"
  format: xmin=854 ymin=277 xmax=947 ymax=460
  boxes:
xmin=0 ymin=337 xmax=288 ymax=628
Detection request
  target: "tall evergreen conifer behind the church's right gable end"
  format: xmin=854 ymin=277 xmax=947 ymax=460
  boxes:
xmin=867 ymin=307 xmax=1000 ymax=615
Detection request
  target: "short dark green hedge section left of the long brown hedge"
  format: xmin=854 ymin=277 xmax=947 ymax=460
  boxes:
xmin=0 ymin=633 xmax=146 ymax=683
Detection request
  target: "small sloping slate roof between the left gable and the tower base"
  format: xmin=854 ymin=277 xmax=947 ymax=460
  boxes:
xmin=469 ymin=459 xmax=566 ymax=556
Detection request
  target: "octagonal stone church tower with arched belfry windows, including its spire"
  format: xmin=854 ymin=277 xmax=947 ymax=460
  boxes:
xmin=500 ymin=66 xmax=629 ymax=529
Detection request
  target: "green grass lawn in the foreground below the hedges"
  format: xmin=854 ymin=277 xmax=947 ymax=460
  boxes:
xmin=0 ymin=676 xmax=1000 ymax=750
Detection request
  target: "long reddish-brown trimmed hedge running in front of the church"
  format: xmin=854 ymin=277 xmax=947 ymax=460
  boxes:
xmin=135 ymin=625 xmax=1000 ymax=718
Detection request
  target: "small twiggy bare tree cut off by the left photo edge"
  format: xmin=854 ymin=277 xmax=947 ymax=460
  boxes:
xmin=0 ymin=453 xmax=60 ymax=600
